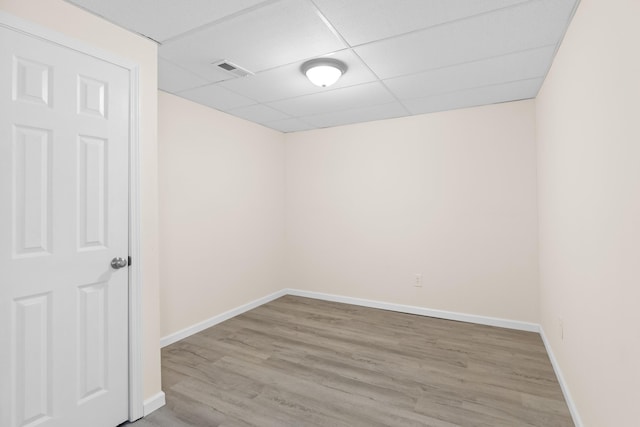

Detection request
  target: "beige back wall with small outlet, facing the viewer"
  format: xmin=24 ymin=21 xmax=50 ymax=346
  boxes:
xmin=285 ymin=101 xmax=539 ymax=323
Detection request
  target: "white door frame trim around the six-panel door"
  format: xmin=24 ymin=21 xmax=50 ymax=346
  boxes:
xmin=0 ymin=10 xmax=144 ymax=421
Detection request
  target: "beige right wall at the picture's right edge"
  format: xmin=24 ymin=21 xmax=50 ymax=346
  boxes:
xmin=536 ymin=0 xmax=640 ymax=427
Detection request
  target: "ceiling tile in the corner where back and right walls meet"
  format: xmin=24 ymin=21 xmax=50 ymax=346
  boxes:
xmin=402 ymin=78 xmax=543 ymax=114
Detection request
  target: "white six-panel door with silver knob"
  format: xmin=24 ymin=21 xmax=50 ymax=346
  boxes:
xmin=0 ymin=21 xmax=129 ymax=427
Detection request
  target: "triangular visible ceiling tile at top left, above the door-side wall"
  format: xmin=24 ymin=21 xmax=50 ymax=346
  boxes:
xmin=68 ymin=0 xmax=265 ymax=42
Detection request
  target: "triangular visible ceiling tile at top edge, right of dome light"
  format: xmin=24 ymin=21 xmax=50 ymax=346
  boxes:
xmin=314 ymin=0 xmax=527 ymax=46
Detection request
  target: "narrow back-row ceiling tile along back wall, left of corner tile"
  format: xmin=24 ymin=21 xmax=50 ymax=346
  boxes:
xmin=302 ymin=102 xmax=407 ymax=128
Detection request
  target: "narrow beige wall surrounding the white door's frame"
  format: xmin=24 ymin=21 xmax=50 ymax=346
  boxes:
xmin=0 ymin=0 xmax=160 ymax=398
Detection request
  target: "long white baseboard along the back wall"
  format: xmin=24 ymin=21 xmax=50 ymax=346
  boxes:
xmin=286 ymin=289 xmax=540 ymax=332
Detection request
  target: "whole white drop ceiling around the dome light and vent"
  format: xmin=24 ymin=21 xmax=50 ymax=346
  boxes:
xmin=68 ymin=0 xmax=579 ymax=132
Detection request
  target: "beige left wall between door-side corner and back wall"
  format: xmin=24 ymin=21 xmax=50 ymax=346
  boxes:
xmin=159 ymin=92 xmax=284 ymax=336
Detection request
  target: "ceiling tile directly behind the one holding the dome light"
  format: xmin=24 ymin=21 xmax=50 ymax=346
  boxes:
xmin=268 ymin=82 xmax=395 ymax=117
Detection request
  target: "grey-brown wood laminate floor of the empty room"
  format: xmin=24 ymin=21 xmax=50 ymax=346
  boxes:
xmin=124 ymin=296 xmax=573 ymax=427
